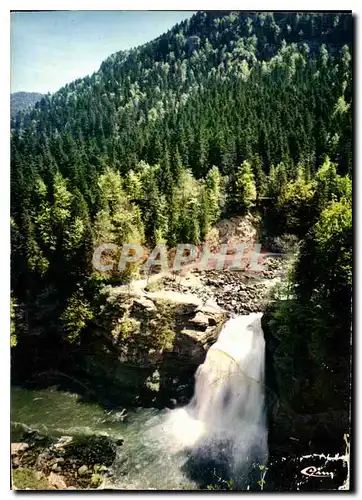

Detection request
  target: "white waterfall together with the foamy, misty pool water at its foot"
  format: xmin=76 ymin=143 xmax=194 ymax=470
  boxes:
xmin=111 ymin=313 xmax=267 ymax=489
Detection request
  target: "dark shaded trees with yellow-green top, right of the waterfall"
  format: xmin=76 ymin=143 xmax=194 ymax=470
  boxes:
xmin=268 ymin=198 xmax=352 ymax=413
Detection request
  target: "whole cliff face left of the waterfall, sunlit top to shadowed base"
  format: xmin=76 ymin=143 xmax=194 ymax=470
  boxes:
xmin=82 ymin=293 xmax=227 ymax=406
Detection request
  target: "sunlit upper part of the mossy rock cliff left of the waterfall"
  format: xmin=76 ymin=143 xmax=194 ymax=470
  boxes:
xmin=97 ymin=291 xmax=227 ymax=367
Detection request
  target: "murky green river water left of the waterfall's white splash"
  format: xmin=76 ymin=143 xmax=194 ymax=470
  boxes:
xmin=11 ymin=387 xmax=201 ymax=489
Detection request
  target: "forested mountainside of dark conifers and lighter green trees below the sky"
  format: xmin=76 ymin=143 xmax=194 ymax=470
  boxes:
xmin=11 ymin=12 xmax=352 ymax=378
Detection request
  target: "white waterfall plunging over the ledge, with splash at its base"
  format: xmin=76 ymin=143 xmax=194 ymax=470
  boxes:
xmin=160 ymin=313 xmax=267 ymax=484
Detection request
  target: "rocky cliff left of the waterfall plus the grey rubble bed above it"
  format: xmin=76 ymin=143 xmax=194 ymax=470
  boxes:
xmin=82 ymin=257 xmax=284 ymax=406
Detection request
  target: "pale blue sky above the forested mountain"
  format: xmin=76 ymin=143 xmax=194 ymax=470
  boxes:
xmin=10 ymin=11 xmax=193 ymax=94
